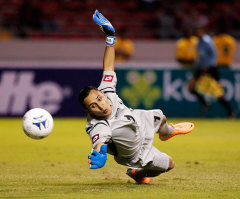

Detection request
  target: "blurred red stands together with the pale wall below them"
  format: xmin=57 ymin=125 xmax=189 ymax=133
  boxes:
xmin=0 ymin=0 xmax=240 ymax=68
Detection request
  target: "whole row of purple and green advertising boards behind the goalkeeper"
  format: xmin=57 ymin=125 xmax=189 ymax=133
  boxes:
xmin=0 ymin=68 xmax=240 ymax=117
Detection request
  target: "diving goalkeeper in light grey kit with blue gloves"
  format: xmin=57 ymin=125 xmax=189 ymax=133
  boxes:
xmin=78 ymin=10 xmax=194 ymax=184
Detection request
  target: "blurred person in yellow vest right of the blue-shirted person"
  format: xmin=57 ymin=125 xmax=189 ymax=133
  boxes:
xmin=213 ymin=26 xmax=236 ymax=68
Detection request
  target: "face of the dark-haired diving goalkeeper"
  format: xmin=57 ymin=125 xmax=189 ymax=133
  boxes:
xmin=84 ymin=90 xmax=112 ymax=118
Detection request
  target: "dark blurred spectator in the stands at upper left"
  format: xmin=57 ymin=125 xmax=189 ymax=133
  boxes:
xmin=18 ymin=0 xmax=43 ymax=38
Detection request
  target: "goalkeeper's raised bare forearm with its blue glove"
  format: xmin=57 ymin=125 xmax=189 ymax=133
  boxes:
xmin=93 ymin=10 xmax=116 ymax=71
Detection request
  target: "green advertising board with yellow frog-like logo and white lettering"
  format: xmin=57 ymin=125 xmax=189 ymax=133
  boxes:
xmin=117 ymin=69 xmax=240 ymax=117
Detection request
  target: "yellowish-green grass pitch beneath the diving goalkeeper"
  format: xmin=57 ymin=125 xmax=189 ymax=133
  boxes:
xmin=0 ymin=118 xmax=240 ymax=199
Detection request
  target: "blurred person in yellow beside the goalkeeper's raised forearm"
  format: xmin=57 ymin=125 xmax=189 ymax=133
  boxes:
xmin=115 ymin=27 xmax=135 ymax=62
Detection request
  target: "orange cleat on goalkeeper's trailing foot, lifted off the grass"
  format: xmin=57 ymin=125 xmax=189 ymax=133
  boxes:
xmin=159 ymin=122 xmax=194 ymax=141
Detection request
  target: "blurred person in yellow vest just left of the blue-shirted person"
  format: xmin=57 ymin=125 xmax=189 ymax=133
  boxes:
xmin=175 ymin=28 xmax=198 ymax=68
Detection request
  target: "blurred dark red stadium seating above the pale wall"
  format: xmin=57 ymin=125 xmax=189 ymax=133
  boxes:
xmin=0 ymin=0 xmax=240 ymax=39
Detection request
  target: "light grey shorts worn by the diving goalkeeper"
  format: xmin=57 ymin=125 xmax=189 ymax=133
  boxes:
xmin=115 ymin=109 xmax=169 ymax=171
